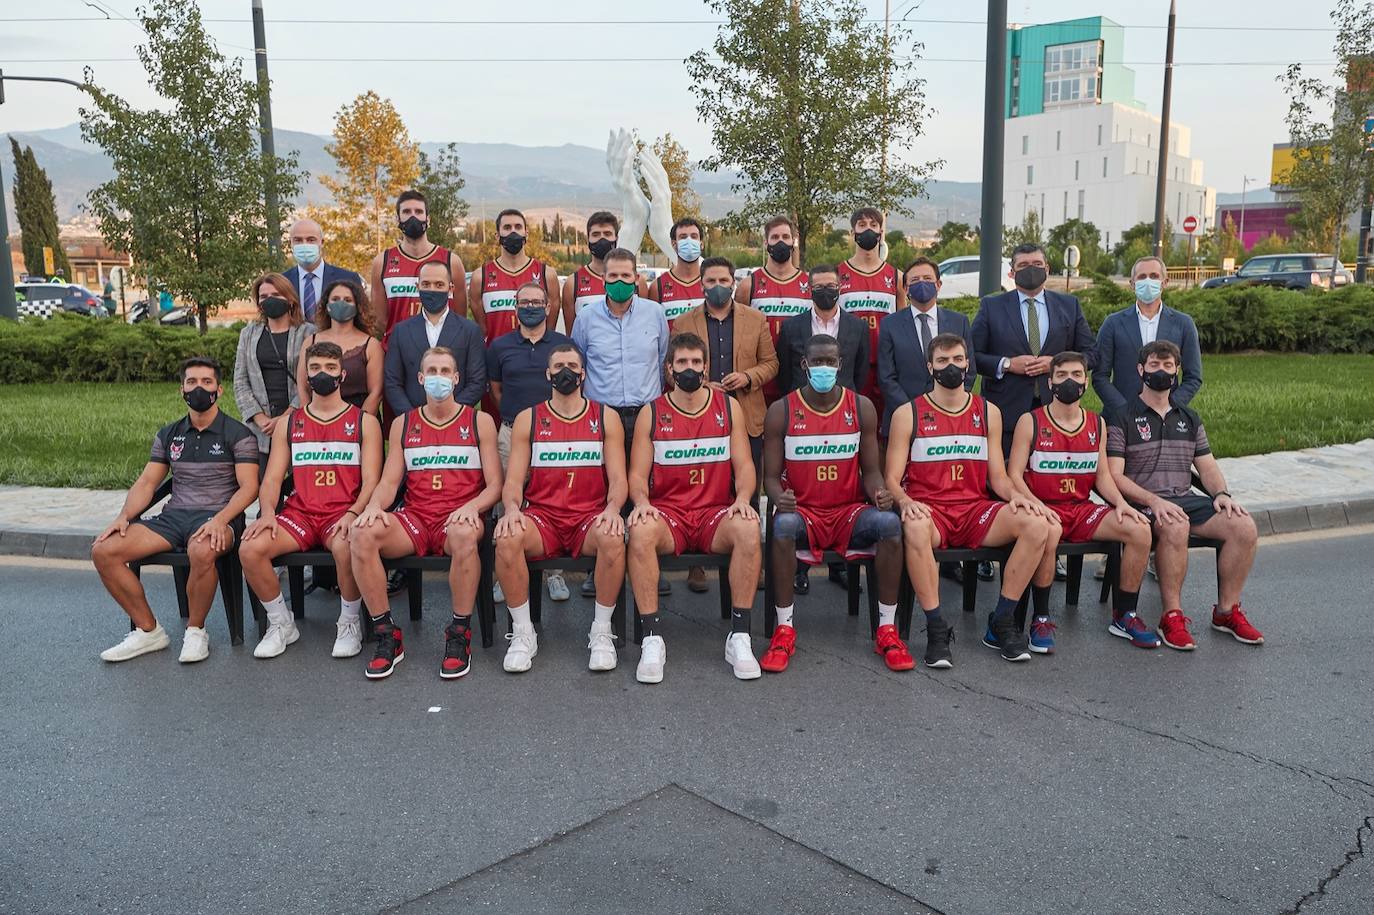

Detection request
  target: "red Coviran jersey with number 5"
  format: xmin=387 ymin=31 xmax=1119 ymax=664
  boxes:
xmin=401 ymin=405 xmax=486 ymax=517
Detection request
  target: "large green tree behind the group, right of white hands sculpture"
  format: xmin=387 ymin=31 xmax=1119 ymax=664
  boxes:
xmin=687 ymin=0 xmax=938 ymax=258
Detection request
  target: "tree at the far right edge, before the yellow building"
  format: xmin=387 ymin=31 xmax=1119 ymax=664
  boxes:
xmin=1281 ymin=0 xmax=1374 ymax=282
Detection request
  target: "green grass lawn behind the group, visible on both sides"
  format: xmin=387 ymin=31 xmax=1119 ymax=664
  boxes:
xmin=0 ymin=354 xmax=1374 ymax=489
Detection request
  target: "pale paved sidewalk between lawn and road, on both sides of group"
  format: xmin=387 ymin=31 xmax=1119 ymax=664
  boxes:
xmin=0 ymin=438 xmax=1374 ymax=559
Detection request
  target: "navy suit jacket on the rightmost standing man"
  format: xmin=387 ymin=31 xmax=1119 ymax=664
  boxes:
xmin=1092 ymin=305 xmax=1202 ymax=416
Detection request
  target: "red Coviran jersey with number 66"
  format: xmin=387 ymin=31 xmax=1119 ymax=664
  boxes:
xmin=783 ymin=387 xmax=868 ymax=508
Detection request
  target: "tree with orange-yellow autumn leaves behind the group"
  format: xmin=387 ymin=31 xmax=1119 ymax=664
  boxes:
xmin=308 ymin=89 xmax=420 ymax=275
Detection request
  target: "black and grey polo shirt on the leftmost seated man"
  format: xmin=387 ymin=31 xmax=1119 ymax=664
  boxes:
xmin=148 ymin=409 xmax=258 ymax=511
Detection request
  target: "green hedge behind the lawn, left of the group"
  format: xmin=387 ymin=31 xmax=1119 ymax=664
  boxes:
xmin=0 ymin=315 xmax=240 ymax=383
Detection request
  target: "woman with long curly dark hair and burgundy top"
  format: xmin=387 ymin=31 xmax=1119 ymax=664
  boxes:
xmin=295 ymin=274 xmax=382 ymax=416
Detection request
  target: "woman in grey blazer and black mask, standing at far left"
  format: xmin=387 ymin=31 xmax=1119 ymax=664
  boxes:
xmin=234 ymin=273 xmax=308 ymax=460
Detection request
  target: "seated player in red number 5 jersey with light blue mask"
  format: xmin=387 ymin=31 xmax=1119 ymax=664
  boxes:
xmin=349 ymin=346 xmax=502 ymax=680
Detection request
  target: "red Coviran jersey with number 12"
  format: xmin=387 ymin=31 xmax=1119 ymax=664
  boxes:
xmin=901 ymin=394 xmax=991 ymax=504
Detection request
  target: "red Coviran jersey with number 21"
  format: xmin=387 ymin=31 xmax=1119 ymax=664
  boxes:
xmin=649 ymin=390 xmax=735 ymax=512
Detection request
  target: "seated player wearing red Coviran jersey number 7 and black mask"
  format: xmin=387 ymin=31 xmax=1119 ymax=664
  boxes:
xmin=496 ymin=343 xmax=627 ymax=673
